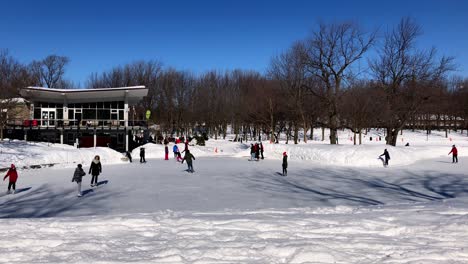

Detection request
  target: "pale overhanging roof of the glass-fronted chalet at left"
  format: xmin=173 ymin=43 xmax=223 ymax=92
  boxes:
xmin=20 ymin=86 xmax=148 ymax=104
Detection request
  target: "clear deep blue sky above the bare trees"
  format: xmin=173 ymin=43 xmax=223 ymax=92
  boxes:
xmin=0 ymin=0 xmax=468 ymax=85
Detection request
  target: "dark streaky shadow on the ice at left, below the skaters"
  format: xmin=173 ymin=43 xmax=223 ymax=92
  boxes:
xmin=0 ymin=185 xmax=119 ymax=218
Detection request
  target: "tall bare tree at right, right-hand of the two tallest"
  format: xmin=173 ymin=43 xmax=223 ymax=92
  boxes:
xmin=370 ymin=18 xmax=453 ymax=146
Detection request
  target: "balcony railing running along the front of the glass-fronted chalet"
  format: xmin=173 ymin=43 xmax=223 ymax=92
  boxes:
xmin=6 ymin=119 xmax=147 ymax=129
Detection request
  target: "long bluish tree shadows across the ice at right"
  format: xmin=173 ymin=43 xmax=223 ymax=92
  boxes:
xmin=247 ymin=169 xmax=468 ymax=206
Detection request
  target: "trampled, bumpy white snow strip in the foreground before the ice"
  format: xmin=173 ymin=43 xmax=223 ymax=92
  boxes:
xmin=0 ymin=202 xmax=468 ymax=264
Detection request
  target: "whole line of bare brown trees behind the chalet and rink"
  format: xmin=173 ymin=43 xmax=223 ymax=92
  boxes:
xmin=0 ymin=18 xmax=468 ymax=145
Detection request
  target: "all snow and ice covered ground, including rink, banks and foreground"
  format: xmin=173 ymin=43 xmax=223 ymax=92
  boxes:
xmin=0 ymin=131 xmax=468 ymax=263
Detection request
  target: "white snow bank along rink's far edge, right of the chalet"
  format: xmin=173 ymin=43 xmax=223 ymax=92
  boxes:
xmin=132 ymin=130 xmax=468 ymax=167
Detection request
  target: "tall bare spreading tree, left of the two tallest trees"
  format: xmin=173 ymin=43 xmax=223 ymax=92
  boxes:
xmin=303 ymin=23 xmax=375 ymax=144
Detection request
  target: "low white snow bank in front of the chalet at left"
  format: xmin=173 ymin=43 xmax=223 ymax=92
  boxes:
xmin=0 ymin=140 xmax=123 ymax=168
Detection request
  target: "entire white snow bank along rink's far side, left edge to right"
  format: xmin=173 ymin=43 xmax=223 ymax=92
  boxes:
xmin=4 ymin=130 xmax=468 ymax=167
